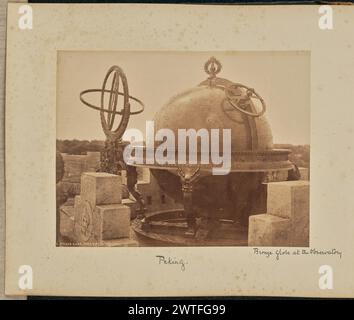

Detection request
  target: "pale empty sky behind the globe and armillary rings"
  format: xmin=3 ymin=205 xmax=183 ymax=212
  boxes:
xmin=57 ymin=51 xmax=310 ymax=144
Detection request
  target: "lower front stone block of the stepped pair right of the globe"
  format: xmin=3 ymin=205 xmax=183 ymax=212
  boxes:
xmin=248 ymin=214 xmax=291 ymax=247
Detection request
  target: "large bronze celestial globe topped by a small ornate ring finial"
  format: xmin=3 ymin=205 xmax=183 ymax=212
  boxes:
xmin=151 ymin=58 xmax=292 ymax=224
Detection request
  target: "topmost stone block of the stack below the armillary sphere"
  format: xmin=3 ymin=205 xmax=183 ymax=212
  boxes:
xmin=80 ymin=172 xmax=122 ymax=208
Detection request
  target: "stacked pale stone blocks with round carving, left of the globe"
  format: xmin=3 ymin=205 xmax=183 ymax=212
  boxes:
xmin=74 ymin=172 xmax=135 ymax=246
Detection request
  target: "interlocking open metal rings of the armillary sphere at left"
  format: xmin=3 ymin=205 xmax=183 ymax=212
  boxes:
xmin=80 ymin=66 xmax=144 ymax=141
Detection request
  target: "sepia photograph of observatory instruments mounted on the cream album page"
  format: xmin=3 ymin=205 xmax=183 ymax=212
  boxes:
xmin=56 ymin=51 xmax=310 ymax=247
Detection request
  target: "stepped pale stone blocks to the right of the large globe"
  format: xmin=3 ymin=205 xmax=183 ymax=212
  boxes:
xmin=248 ymin=180 xmax=310 ymax=247
